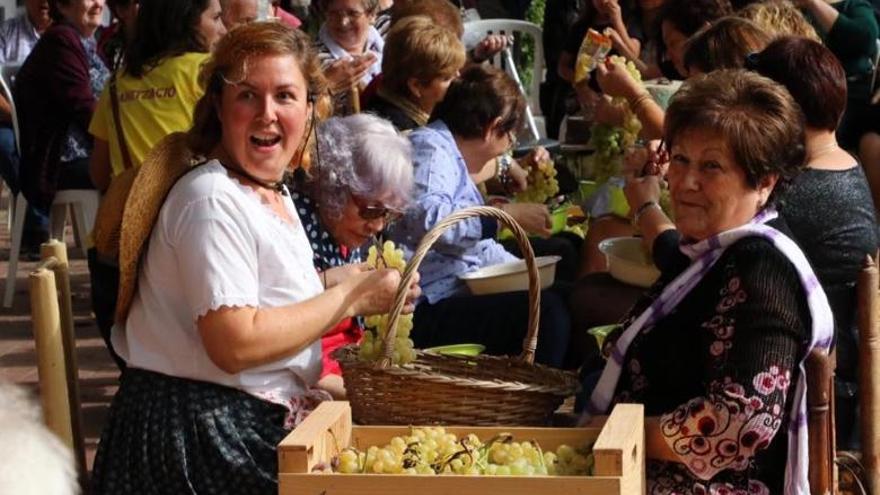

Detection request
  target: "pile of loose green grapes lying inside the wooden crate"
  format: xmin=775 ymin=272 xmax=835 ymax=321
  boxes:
xmin=333 ymin=427 xmax=593 ymax=476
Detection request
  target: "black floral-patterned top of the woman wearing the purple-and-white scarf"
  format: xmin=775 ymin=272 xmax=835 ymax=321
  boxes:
xmin=614 ymin=231 xmax=811 ymax=493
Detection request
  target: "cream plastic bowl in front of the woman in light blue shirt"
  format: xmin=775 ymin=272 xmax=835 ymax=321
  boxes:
xmin=458 ymin=256 xmax=561 ymax=296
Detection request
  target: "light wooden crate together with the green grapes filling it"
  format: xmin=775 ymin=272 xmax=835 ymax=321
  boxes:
xmin=278 ymin=402 xmax=645 ymax=495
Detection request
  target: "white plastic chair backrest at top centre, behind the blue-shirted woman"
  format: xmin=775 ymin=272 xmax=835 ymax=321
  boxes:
xmin=464 ymin=19 xmax=544 ymax=115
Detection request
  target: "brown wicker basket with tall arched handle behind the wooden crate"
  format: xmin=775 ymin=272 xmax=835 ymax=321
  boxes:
xmin=333 ymin=206 xmax=578 ymax=426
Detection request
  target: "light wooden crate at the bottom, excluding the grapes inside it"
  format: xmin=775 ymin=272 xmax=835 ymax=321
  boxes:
xmin=278 ymin=402 xmax=645 ymax=495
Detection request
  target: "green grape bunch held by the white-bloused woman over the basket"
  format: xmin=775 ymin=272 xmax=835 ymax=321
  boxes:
xmin=358 ymin=241 xmax=416 ymax=365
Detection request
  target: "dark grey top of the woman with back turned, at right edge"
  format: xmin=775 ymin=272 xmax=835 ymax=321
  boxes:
xmin=780 ymin=165 xmax=877 ymax=382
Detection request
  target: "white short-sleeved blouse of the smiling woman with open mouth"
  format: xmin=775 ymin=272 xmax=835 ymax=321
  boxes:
xmin=112 ymin=160 xmax=323 ymax=405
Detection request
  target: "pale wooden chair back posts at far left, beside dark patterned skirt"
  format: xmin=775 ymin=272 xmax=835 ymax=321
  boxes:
xmin=29 ymin=239 xmax=86 ymax=484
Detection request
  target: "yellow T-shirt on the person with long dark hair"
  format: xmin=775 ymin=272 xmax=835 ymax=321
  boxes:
xmin=89 ymin=52 xmax=208 ymax=177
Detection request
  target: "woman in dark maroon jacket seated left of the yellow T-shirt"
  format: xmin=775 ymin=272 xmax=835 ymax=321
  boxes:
xmin=13 ymin=0 xmax=110 ymax=253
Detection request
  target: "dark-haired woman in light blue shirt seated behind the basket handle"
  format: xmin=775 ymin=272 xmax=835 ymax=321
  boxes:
xmin=390 ymin=65 xmax=570 ymax=367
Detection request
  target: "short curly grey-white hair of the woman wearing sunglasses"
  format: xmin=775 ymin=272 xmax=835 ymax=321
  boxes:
xmin=307 ymin=113 xmax=413 ymax=220
